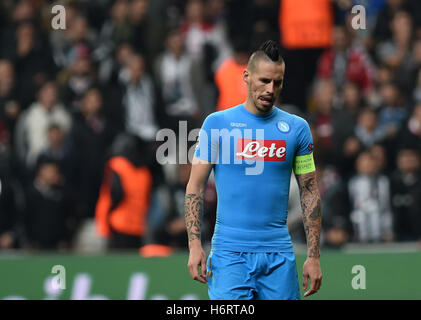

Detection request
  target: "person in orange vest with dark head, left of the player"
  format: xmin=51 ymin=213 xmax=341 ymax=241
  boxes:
xmin=95 ymin=135 xmax=153 ymax=249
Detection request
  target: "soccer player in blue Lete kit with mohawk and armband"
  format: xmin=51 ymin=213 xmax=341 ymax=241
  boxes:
xmin=185 ymin=40 xmax=322 ymax=300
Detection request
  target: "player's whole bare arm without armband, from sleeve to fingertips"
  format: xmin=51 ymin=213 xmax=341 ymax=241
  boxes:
xmin=184 ymin=158 xmax=212 ymax=283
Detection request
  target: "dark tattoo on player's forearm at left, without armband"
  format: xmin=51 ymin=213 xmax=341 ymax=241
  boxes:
xmin=184 ymin=192 xmax=203 ymax=242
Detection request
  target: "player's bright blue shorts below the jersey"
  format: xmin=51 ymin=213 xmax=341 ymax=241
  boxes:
xmin=207 ymin=250 xmax=300 ymax=300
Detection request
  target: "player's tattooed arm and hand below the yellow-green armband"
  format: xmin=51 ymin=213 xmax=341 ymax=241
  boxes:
xmin=296 ymin=171 xmax=322 ymax=297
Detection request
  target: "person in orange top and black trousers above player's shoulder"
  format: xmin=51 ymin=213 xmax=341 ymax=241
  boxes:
xmin=278 ymin=0 xmax=334 ymax=112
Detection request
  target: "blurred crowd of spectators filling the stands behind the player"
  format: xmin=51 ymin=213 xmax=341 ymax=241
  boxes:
xmin=0 ymin=0 xmax=421 ymax=254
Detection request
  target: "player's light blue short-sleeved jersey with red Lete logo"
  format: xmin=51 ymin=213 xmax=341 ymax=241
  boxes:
xmin=195 ymin=104 xmax=313 ymax=252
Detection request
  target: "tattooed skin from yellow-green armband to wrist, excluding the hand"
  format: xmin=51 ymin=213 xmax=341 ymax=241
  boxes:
xmin=297 ymin=172 xmax=322 ymax=258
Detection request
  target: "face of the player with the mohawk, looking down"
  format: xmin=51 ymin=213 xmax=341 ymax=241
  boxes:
xmin=244 ymin=60 xmax=285 ymax=113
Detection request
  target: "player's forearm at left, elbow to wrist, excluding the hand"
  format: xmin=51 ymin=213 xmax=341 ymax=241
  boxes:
xmin=184 ymin=185 xmax=204 ymax=248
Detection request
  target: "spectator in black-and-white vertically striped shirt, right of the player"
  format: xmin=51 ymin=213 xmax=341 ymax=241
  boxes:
xmin=348 ymin=151 xmax=393 ymax=242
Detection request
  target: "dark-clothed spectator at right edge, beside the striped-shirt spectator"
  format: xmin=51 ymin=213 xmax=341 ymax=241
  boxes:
xmin=391 ymin=149 xmax=421 ymax=241
